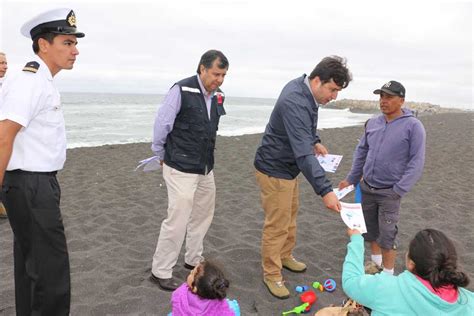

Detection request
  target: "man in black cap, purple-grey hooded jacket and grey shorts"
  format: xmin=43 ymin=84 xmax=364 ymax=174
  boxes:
xmin=339 ymin=80 xmax=426 ymax=274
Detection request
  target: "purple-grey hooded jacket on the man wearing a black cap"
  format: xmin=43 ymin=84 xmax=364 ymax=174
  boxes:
xmin=346 ymin=109 xmax=426 ymax=196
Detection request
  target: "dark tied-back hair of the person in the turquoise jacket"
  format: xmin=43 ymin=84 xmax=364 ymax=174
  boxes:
xmin=408 ymin=229 xmax=469 ymax=289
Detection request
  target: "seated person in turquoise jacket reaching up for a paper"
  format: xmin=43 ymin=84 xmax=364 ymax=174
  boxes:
xmin=342 ymin=229 xmax=474 ymax=316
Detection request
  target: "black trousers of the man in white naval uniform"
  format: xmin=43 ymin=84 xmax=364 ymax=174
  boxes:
xmin=3 ymin=170 xmax=71 ymax=316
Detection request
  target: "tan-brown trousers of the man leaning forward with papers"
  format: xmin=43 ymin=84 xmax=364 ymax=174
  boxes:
xmin=256 ymin=170 xmax=299 ymax=281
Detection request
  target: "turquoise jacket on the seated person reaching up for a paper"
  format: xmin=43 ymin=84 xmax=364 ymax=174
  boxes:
xmin=342 ymin=234 xmax=474 ymax=316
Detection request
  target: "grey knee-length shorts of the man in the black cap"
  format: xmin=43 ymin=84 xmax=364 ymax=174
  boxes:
xmin=360 ymin=181 xmax=401 ymax=250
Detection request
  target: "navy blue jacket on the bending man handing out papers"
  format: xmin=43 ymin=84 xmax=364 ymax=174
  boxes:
xmin=254 ymin=75 xmax=332 ymax=196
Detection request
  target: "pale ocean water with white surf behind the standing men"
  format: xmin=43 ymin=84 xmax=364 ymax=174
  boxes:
xmin=61 ymin=93 xmax=372 ymax=148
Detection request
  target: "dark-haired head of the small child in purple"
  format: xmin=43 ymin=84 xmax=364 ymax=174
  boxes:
xmin=193 ymin=260 xmax=229 ymax=299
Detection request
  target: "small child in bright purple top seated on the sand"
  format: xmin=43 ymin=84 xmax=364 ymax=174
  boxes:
xmin=168 ymin=261 xmax=240 ymax=316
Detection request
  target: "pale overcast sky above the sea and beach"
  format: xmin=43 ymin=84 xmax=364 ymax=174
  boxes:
xmin=0 ymin=0 xmax=473 ymax=108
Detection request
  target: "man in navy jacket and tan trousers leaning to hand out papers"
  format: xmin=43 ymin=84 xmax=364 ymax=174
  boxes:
xmin=254 ymin=56 xmax=351 ymax=299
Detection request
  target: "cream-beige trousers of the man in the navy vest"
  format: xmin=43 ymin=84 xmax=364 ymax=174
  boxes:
xmin=151 ymin=164 xmax=216 ymax=279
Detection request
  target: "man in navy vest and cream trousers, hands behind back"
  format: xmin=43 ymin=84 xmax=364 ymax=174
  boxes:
xmin=151 ymin=50 xmax=229 ymax=291
